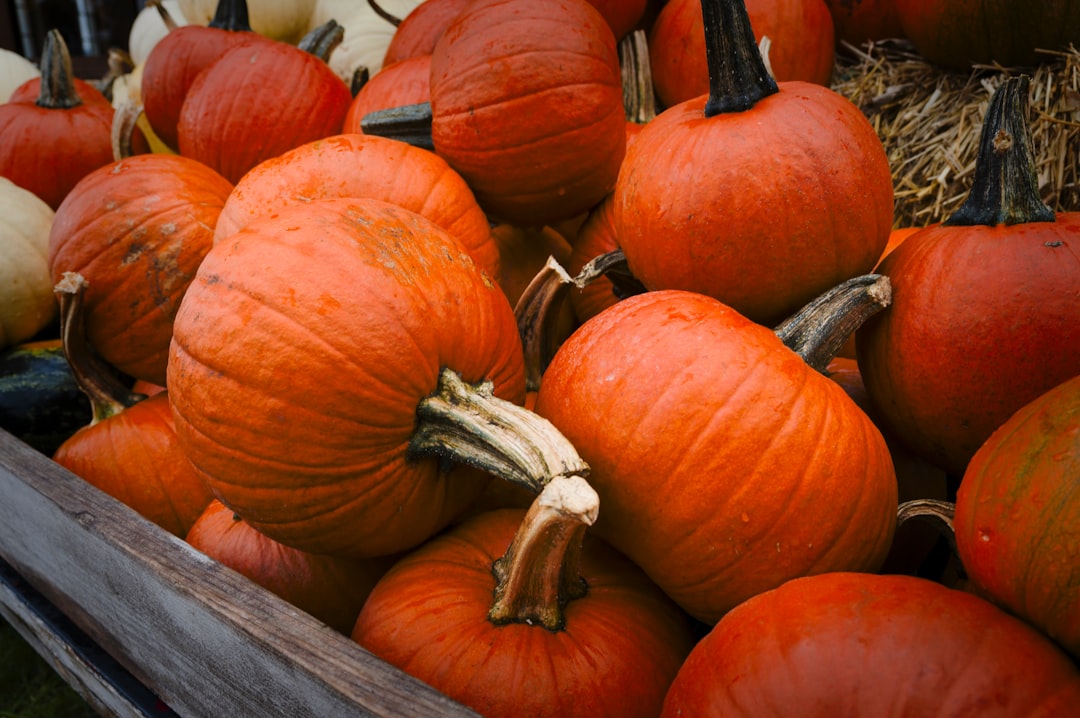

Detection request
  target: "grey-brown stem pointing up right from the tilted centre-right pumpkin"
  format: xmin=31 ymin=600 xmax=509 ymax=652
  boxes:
xmin=773 ymin=274 xmax=892 ymax=374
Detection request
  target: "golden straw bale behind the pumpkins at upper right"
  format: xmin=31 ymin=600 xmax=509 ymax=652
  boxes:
xmin=832 ymin=40 xmax=1080 ymax=227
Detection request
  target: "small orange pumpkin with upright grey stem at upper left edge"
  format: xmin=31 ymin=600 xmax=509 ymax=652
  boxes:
xmin=0 ymin=30 xmax=148 ymax=209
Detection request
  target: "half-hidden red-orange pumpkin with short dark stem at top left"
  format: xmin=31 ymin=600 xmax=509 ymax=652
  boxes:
xmin=139 ymin=0 xmax=267 ymax=149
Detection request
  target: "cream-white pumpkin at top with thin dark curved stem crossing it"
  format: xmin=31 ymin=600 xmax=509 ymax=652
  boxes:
xmin=308 ymin=0 xmax=423 ymax=84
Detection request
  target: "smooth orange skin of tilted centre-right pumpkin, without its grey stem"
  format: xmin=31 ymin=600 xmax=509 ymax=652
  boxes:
xmin=536 ymin=290 xmax=896 ymax=622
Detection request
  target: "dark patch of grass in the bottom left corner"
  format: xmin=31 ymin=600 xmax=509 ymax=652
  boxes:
xmin=0 ymin=619 xmax=97 ymax=718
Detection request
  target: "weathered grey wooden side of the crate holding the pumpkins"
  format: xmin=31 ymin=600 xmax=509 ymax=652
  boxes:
xmin=0 ymin=430 xmax=476 ymax=718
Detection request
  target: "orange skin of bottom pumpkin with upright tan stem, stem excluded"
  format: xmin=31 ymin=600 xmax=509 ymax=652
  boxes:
xmin=352 ymin=509 xmax=691 ymax=718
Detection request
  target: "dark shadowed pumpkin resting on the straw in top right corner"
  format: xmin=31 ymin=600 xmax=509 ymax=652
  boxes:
xmin=892 ymin=0 xmax=1080 ymax=71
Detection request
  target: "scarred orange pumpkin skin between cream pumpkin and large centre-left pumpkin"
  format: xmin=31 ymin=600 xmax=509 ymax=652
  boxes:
xmin=49 ymin=154 xmax=232 ymax=385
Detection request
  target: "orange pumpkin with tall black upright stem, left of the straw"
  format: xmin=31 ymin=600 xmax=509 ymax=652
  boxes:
xmin=615 ymin=0 xmax=893 ymax=325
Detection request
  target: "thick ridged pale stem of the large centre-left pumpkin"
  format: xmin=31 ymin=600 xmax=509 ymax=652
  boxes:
xmin=408 ymin=368 xmax=589 ymax=493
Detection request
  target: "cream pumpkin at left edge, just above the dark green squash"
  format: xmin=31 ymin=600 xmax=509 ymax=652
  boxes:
xmin=0 ymin=177 xmax=57 ymax=349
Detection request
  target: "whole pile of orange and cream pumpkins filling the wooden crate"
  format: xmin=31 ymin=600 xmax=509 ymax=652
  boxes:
xmin=0 ymin=0 xmax=1080 ymax=716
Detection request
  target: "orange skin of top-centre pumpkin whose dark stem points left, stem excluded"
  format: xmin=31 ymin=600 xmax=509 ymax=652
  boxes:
xmin=431 ymin=0 xmax=626 ymax=226
